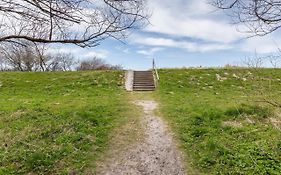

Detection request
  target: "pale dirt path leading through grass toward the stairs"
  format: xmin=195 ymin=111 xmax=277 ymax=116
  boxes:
xmin=97 ymin=100 xmax=186 ymax=175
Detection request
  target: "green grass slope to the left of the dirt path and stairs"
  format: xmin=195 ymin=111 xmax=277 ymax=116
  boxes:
xmin=0 ymin=71 xmax=129 ymax=174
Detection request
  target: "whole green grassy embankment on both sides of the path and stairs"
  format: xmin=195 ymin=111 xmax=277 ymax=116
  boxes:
xmin=0 ymin=69 xmax=281 ymax=175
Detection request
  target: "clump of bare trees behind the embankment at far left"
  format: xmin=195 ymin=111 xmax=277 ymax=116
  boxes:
xmin=0 ymin=42 xmax=76 ymax=72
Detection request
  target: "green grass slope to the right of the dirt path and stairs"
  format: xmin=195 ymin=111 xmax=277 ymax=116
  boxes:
xmin=156 ymin=69 xmax=281 ymax=175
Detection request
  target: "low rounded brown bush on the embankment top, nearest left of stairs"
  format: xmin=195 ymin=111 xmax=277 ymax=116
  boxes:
xmin=76 ymin=57 xmax=122 ymax=71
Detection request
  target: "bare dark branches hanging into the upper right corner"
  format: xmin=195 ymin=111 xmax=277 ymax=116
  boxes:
xmin=211 ymin=0 xmax=281 ymax=36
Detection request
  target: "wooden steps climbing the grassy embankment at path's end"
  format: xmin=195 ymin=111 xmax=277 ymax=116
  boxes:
xmin=133 ymin=71 xmax=155 ymax=91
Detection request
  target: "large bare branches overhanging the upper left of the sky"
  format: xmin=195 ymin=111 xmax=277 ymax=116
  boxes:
xmin=0 ymin=0 xmax=147 ymax=47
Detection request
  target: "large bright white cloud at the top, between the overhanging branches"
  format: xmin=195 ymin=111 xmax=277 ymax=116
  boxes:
xmin=145 ymin=0 xmax=242 ymax=43
